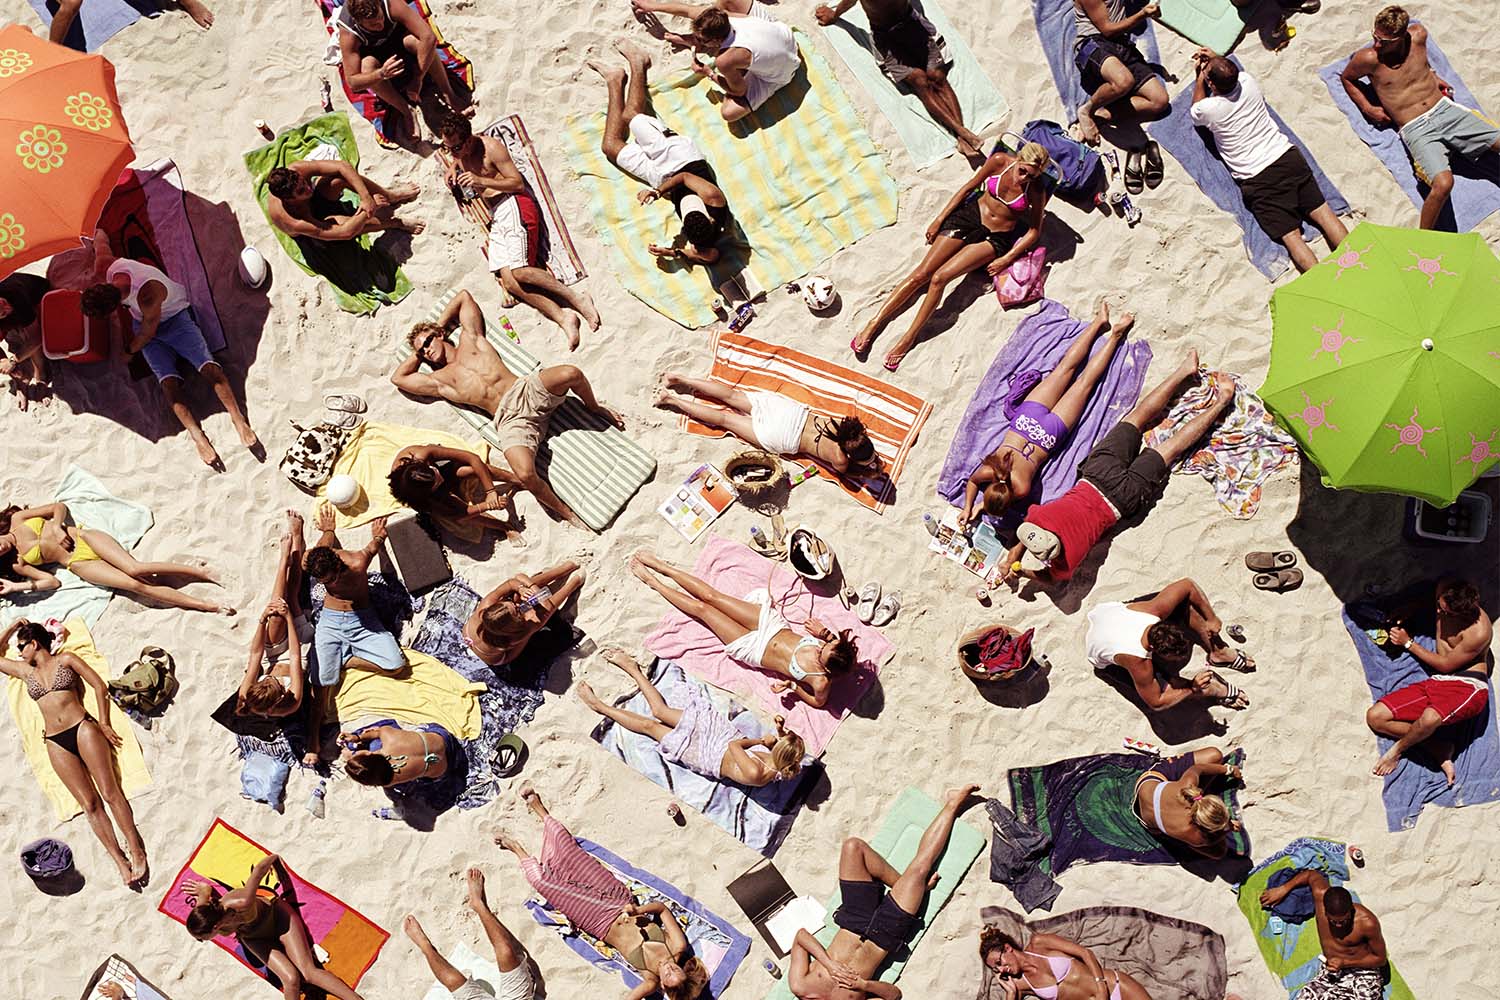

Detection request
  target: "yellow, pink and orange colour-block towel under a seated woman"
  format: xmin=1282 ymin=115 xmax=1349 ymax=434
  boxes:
xmin=156 ymin=819 xmax=390 ymax=987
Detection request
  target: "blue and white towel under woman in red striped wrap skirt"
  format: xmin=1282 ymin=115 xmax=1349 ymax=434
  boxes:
xmin=527 ymin=837 xmax=750 ymax=997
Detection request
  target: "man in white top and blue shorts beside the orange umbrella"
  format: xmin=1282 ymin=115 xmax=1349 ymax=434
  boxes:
xmin=83 ymin=232 xmax=266 ymax=472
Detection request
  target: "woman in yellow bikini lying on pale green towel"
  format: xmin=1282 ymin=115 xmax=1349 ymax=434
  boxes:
xmin=0 ymin=504 xmax=234 ymax=615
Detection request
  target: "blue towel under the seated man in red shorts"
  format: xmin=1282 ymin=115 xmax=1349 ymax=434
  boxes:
xmin=1343 ymin=606 xmax=1500 ymax=831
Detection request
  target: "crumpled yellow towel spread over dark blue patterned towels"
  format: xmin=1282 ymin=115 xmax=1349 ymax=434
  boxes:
xmin=333 ymin=649 xmax=485 ymax=739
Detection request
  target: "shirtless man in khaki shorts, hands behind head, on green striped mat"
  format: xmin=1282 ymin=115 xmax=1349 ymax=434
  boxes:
xmin=390 ymin=291 xmax=626 ymax=528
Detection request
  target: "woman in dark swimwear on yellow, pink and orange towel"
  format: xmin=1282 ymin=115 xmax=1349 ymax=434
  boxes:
xmin=182 ymin=855 xmax=365 ymax=1000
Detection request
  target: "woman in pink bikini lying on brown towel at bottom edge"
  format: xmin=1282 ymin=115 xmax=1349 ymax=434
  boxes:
xmin=980 ymin=927 xmax=1151 ymax=1000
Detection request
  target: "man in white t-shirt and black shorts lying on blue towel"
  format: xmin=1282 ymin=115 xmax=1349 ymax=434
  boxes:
xmin=1188 ymin=48 xmax=1349 ymax=271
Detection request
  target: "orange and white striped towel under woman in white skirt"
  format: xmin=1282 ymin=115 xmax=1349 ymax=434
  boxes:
xmin=678 ymin=330 xmax=933 ymax=514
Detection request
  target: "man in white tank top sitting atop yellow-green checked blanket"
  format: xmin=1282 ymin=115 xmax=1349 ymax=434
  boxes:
xmin=632 ymin=0 xmax=803 ymax=121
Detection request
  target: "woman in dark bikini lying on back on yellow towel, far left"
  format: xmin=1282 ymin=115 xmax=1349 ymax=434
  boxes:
xmin=0 ymin=618 xmax=150 ymax=889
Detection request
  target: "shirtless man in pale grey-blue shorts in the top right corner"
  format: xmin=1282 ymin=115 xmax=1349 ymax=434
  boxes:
xmin=1340 ymin=6 xmax=1500 ymax=229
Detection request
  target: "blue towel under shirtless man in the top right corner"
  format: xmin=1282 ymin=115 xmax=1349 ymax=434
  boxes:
xmin=1317 ymin=34 xmax=1500 ymax=232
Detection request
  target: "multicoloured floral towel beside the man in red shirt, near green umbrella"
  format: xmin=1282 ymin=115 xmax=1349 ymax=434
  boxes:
xmin=1146 ymin=369 xmax=1298 ymax=520
